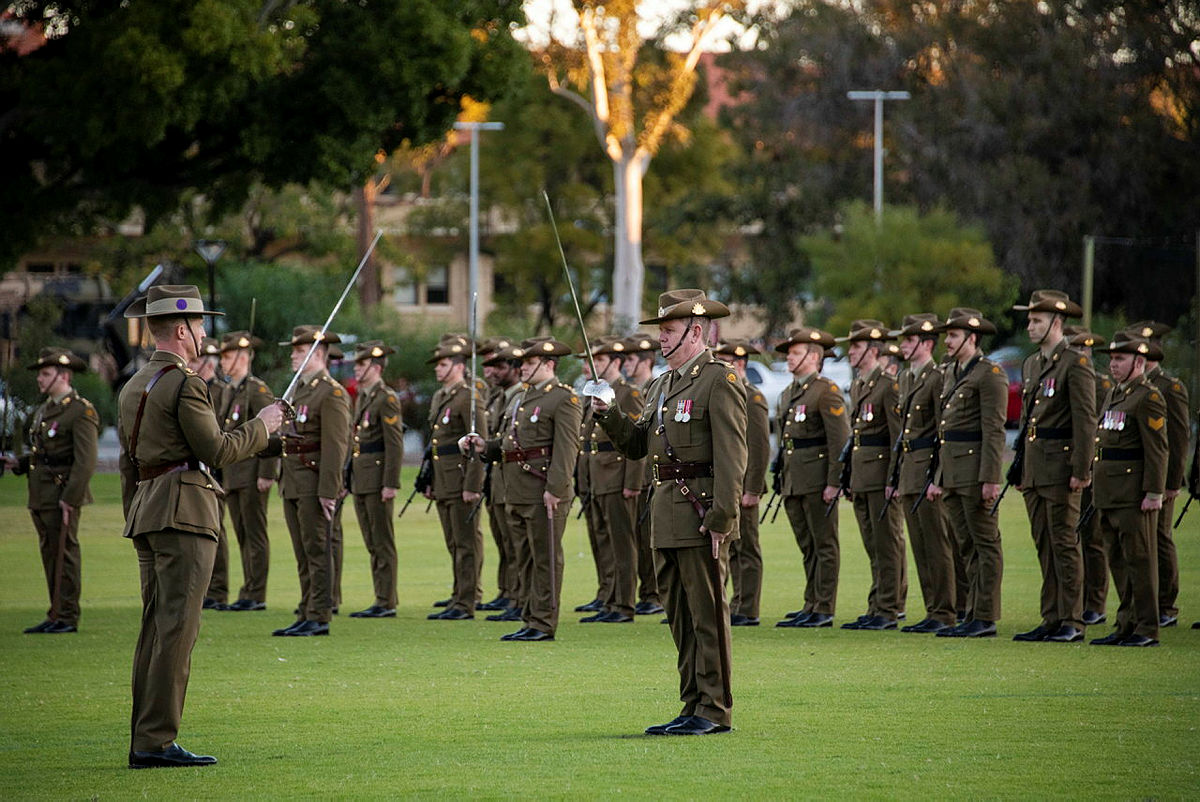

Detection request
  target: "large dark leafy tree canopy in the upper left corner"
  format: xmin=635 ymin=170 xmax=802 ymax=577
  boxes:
xmin=0 ymin=0 xmax=527 ymax=268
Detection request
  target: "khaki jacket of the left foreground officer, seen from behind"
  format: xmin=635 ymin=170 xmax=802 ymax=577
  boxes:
xmin=118 ymin=351 xmax=268 ymax=540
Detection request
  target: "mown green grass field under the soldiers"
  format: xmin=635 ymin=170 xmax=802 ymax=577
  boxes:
xmin=0 ymin=469 xmax=1200 ymax=800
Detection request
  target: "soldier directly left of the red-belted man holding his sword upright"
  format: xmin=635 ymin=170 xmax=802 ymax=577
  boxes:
xmin=425 ymin=335 xmax=477 ymax=621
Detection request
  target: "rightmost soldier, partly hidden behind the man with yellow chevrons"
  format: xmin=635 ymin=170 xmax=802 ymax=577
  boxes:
xmin=1126 ymin=321 xmax=1192 ymax=627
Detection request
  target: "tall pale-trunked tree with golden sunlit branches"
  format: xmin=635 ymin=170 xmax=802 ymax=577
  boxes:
xmin=542 ymin=0 xmax=742 ymax=331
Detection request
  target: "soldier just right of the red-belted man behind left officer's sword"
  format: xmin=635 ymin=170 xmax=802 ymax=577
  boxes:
xmin=347 ymin=340 xmax=404 ymax=618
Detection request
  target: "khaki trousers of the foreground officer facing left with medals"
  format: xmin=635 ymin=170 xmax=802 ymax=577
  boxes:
xmin=654 ymin=540 xmax=733 ymax=726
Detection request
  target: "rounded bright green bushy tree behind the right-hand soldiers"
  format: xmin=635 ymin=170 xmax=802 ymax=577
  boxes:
xmin=802 ymin=201 xmax=1018 ymax=331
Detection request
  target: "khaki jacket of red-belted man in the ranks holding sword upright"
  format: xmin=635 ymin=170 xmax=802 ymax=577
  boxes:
xmin=485 ymin=378 xmax=583 ymax=504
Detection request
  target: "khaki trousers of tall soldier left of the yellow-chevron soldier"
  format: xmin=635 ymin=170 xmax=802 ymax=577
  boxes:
xmin=1021 ymin=485 xmax=1084 ymax=629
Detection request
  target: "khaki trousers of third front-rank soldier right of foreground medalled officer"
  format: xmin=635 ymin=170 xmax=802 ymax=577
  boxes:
xmin=853 ymin=490 xmax=908 ymax=621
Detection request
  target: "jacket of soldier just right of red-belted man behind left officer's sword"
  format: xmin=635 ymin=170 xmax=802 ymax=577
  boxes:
xmin=348 ymin=381 xmax=404 ymax=493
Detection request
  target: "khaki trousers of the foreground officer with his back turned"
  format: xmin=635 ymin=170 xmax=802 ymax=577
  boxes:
xmin=130 ymin=529 xmax=217 ymax=752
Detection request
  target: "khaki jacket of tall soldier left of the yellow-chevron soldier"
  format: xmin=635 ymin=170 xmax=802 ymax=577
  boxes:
xmin=1021 ymin=337 xmax=1096 ymax=487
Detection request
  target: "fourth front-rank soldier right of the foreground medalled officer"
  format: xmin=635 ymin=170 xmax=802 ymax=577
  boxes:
xmin=886 ymin=312 xmax=955 ymax=634
